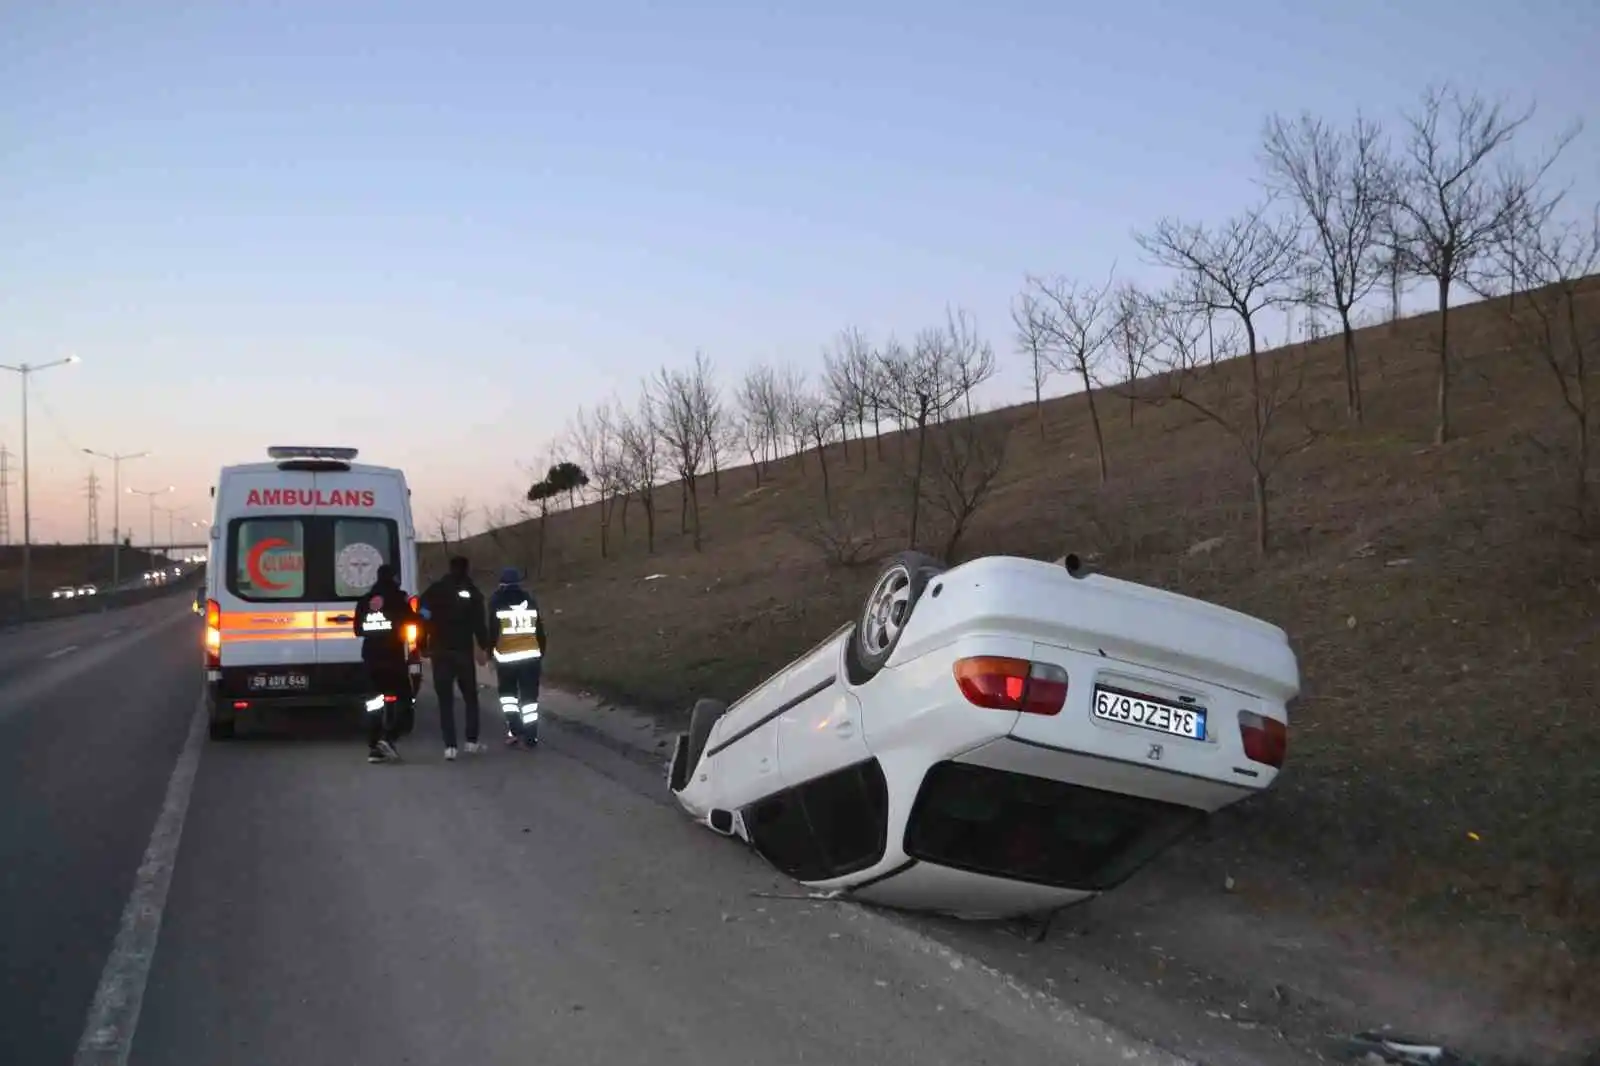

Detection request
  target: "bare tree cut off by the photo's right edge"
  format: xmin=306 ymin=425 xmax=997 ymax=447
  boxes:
xmin=1498 ymin=208 xmax=1600 ymax=533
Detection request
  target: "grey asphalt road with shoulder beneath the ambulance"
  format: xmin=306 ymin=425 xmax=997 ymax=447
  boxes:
xmin=0 ymin=600 xmax=1190 ymax=1066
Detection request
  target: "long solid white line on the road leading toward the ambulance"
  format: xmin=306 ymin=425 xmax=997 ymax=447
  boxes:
xmin=72 ymin=707 xmax=205 ymax=1066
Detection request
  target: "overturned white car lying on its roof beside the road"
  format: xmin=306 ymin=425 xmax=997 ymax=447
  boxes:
xmin=669 ymin=552 xmax=1299 ymax=917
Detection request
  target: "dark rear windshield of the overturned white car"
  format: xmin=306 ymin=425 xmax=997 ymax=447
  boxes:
xmin=906 ymin=762 xmax=1205 ymax=892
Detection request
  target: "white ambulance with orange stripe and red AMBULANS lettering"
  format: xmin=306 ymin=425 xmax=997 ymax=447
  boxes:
xmin=205 ymin=447 xmax=422 ymax=739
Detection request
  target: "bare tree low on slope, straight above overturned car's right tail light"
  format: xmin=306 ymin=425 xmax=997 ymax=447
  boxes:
xmin=1138 ymin=206 xmax=1310 ymax=554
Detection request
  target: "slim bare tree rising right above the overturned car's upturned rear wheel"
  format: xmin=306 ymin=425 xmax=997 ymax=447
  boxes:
xmin=878 ymin=315 xmax=995 ymax=547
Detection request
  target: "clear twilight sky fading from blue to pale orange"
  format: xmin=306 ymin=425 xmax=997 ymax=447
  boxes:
xmin=0 ymin=0 xmax=1600 ymax=543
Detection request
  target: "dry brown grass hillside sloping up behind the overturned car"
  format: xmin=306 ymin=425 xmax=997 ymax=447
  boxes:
xmin=432 ymin=278 xmax=1600 ymax=1020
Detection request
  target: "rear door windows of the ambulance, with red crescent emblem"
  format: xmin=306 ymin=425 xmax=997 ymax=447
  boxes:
xmin=227 ymin=515 xmax=400 ymax=603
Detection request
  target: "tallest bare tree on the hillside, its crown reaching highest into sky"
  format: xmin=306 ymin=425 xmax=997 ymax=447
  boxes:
xmin=1390 ymin=88 xmax=1576 ymax=443
